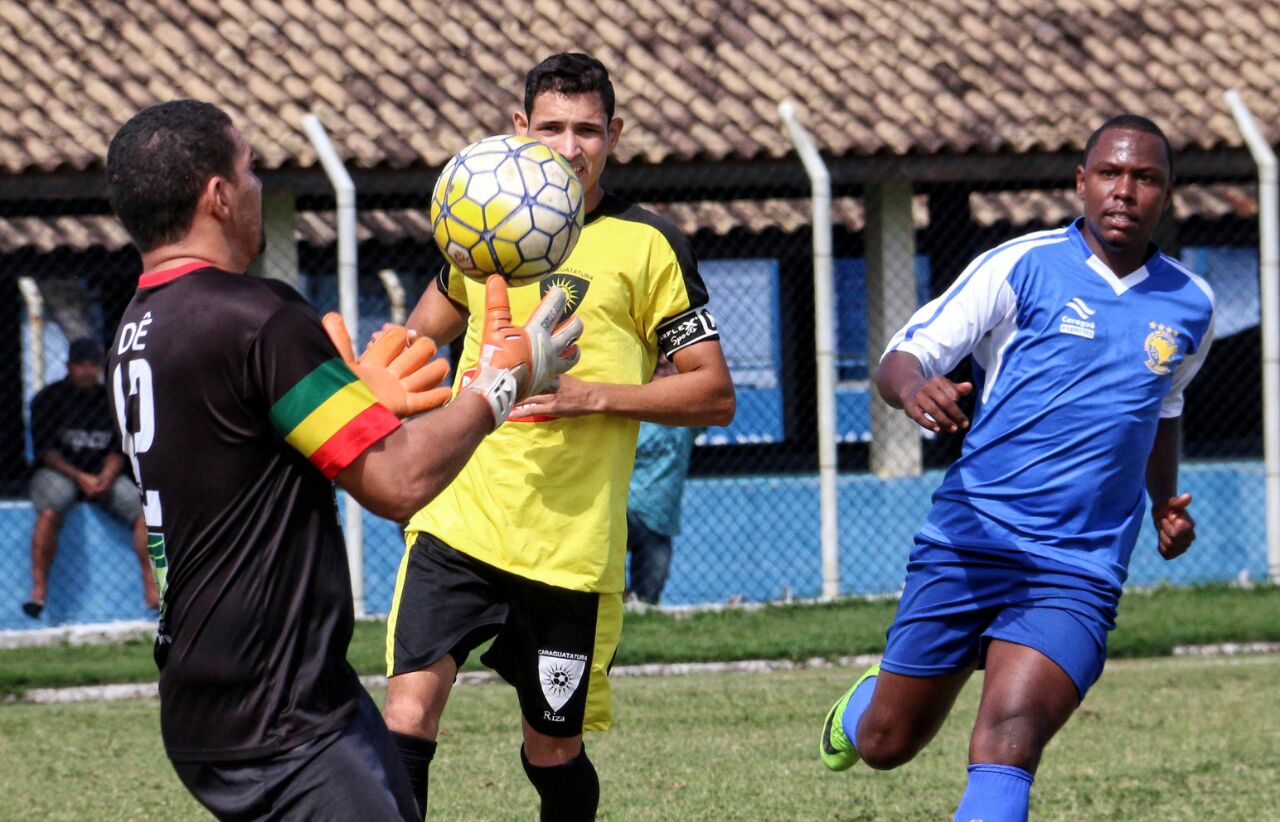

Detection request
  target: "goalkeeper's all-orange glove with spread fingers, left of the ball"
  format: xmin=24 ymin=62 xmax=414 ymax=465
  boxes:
xmin=320 ymin=311 xmax=453 ymax=417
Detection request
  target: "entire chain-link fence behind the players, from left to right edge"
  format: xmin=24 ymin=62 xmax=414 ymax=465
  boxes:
xmin=0 ymin=154 xmax=1266 ymax=630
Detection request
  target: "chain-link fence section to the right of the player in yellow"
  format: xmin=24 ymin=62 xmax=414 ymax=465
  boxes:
xmin=634 ymin=179 xmax=1266 ymax=603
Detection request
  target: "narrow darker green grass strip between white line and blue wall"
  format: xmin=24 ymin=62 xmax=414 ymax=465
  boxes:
xmin=0 ymin=585 xmax=1280 ymax=694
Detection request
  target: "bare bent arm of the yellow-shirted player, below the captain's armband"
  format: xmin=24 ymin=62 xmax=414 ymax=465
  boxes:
xmin=512 ymin=339 xmax=736 ymax=425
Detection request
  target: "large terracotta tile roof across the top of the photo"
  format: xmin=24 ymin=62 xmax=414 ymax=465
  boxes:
xmin=0 ymin=0 xmax=1280 ymax=173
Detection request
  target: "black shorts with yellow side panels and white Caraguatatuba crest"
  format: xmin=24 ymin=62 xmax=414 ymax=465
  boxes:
xmin=387 ymin=534 xmax=622 ymax=737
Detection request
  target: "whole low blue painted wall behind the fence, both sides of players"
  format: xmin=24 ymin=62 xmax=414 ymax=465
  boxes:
xmin=0 ymin=461 xmax=1266 ymax=630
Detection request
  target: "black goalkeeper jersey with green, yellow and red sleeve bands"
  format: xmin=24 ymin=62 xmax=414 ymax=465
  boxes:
xmin=108 ymin=265 xmax=399 ymax=761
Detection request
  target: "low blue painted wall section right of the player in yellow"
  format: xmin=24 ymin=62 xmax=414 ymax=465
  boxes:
xmin=663 ymin=461 xmax=1267 ymax=604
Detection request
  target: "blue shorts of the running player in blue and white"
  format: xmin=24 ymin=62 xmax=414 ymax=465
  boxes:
xmin=881 ymin=538 xmax=1120 ymax=699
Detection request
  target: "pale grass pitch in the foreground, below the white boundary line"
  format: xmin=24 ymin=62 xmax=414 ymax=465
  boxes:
xmin=0 ymin=656 xmax=1280 ymax=821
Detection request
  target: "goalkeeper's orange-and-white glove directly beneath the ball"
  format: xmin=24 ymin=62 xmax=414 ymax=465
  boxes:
xmin=463 ymin=274 xmax=582 ymax=425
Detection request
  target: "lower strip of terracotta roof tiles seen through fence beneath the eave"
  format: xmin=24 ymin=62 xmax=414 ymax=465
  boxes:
xmin=0 ymin=184 xmax=1258 ymax=254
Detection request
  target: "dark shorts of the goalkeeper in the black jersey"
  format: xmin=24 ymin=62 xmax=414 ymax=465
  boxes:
xmin=173 ymin=694 xmax=422 ymax=822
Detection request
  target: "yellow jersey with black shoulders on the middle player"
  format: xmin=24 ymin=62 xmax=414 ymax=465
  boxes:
xmin=406 ymin=195 xmax=718 ymax=593
